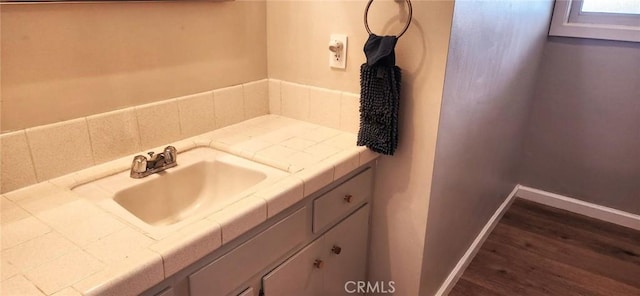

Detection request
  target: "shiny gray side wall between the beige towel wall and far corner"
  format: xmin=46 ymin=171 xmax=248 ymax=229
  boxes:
xmin=420 ymin=0 xmax=553 ymax=295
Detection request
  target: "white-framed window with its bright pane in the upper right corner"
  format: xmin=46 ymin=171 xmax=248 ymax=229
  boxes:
xmin=549 ymin=0 xmax=640 ymax=42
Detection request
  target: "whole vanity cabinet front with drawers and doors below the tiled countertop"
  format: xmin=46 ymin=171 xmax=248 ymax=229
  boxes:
xmin=143 ymin=167 xmax=373 ymax=296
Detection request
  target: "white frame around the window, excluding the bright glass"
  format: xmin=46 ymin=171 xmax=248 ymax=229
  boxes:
xmin=549 ymin=0 xmax=640 ymax=42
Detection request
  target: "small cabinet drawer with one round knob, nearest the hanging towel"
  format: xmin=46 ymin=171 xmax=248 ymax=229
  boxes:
xmin=313 ymin=169 xmax=373 ymax=233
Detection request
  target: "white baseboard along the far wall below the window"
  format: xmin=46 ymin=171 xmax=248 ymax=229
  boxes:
xmin=516 ymin=185 xmax=640 ymax=230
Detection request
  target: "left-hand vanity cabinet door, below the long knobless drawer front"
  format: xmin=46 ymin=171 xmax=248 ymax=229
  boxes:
xmin=262 ymin=239 xmax=327 ymax=296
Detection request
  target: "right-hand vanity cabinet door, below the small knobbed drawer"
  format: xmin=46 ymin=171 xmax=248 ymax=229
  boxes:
xmin=323 ymin=205 xmax=369 ymax=296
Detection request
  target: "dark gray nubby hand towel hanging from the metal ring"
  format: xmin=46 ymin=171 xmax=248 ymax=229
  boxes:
xmin=358 ymin=34 xmax=401 ymax=155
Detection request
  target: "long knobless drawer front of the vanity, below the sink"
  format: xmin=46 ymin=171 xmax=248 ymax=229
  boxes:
xmin=189 ymin=208 xmax=309 ymax=296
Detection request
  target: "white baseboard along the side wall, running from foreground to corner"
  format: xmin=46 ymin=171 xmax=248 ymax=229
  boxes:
xmin=436 ymin=185 xmax=520 ymax=296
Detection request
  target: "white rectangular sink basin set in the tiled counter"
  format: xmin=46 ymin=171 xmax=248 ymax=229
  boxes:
xmin=73 ymin=147 xmax=287 ymax=237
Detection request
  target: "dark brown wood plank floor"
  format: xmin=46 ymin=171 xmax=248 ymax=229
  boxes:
xmin=449 ymin=199 xmax=640 ymax=296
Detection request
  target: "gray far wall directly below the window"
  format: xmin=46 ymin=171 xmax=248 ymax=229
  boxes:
xmin=521 ymin=38 xmax=640 ymax=214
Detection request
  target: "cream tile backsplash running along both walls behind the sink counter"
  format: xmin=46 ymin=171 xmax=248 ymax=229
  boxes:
xmin=0 ymin=79 xmax=360 ymax=192
